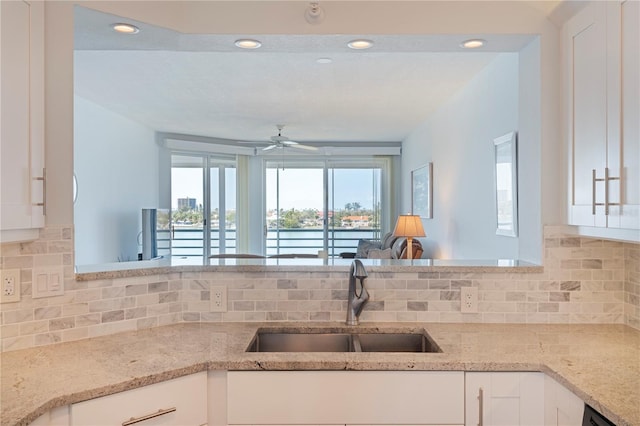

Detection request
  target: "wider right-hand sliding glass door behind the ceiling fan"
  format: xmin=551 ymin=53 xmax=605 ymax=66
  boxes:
xmin=265 ymin=158 xmax=388 ymax=256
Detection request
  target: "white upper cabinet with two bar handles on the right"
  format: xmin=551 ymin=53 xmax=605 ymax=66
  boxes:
xmin=563 ymin=1 xmax=640 ymax=235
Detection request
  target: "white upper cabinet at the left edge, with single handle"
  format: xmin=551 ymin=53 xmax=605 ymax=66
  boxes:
xmin=0 ymin=1 xmax=46 ymax=242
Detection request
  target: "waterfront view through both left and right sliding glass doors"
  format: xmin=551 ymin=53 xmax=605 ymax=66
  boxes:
xmin=168 ymin=155 xmax=382 ymax=257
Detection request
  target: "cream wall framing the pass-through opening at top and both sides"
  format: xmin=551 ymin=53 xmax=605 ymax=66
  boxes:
xmin=45 ymin=1 xmax=566 ymax=262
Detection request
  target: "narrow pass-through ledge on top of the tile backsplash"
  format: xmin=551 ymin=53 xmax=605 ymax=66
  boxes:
xmin=76 ymin=258 xmax=543 ymax=281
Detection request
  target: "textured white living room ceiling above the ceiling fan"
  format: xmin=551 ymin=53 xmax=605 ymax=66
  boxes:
xmin=74 ymin=8 xmax=531 ymax=142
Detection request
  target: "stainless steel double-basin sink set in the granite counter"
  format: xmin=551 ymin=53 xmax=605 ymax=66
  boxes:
xmin=247 ymin=329 xmax=442 ymax=352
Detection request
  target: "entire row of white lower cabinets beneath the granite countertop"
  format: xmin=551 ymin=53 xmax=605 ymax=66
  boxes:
xmin=31 ymin=370 xmax=584 ymax=426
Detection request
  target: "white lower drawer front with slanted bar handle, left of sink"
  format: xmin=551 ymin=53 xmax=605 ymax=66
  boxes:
xmin=71 ymin=372 xmax=207 ymax=426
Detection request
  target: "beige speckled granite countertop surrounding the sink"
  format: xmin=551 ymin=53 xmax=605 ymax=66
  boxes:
xmin=0 ymin=323 xmax=640 ymax=426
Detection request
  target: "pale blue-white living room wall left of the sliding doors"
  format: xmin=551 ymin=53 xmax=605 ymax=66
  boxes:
xmin=74 ymin=96 xmax=159 ymax=265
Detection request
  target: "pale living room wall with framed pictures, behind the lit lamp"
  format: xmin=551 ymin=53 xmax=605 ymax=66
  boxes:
xmin=402 ymin=53 xmax=519 ymax=259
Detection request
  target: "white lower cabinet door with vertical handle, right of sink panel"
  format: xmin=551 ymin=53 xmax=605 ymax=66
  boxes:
xmin=465 ymin=373 xmax=544 ymax=426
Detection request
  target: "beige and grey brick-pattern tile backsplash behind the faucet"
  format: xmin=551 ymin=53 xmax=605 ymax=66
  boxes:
xmin=0 ymin=226 xmax=640 ymax=351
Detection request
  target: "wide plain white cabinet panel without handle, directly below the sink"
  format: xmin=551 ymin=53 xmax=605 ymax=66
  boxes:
xmin=226 ymin=371 xmax=464 ymax=425
